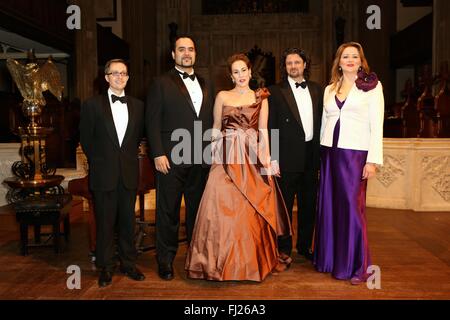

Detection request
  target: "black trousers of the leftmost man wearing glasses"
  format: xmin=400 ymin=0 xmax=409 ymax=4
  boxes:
xmin=93 ymin=181 xmax=137 ymax=271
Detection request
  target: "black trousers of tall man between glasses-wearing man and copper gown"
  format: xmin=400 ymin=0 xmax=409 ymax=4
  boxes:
xmin=156 ymin=165 xmax=209 ymax=264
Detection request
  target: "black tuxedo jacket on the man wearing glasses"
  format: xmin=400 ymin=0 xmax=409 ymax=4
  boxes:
xmin=80 ymin=94 xmax=144 ymax=191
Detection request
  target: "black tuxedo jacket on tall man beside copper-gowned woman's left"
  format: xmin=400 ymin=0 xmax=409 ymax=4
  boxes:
xmin=145 ymin=68 xmax=214 ymax=166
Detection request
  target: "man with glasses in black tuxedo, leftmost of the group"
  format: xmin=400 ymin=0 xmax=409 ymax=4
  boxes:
xmin=80 ymin=59 xmax=145 ymax=287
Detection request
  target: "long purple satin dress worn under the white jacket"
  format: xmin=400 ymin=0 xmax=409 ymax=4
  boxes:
xmin=314 ymin=97 xmax=370 ymax=281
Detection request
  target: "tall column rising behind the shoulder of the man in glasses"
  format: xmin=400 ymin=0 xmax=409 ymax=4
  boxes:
xmin=72 ymin=0 xmax=98 ymax=101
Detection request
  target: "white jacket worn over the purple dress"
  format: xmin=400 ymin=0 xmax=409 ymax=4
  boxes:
xmin=320 ymin=82 xmax=384 ymax=165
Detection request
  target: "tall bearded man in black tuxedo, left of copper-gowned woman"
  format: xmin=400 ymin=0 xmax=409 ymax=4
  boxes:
xmin=145 ymin=36 xmax=214 ymax=280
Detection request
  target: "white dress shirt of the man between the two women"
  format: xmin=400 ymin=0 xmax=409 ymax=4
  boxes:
xmin=288 ymin=77 xmax=314 ymax=142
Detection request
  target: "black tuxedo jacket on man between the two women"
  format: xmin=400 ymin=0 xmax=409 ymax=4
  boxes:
xmin=269 ymin=80 xmax=323 ymax=172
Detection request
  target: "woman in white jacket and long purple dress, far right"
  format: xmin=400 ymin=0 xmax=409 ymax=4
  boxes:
xmin=314 ymin=42 xmax=384 ymax=284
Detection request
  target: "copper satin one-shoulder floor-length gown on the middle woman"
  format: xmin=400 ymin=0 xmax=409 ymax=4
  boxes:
xmin=185 ymin=89 xmax=291 ymax=281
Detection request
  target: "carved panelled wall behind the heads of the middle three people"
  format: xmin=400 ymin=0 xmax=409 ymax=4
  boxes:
xmin=190 ymin=13 xmax=325 ymax=90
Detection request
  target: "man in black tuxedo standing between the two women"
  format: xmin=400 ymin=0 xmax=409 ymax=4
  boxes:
xmin=269 ymin=48 xmax=323 ymax=260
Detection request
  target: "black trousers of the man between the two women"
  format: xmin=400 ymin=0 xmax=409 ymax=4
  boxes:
xmin=278 ymin=154 xmax=318 ymax=255
